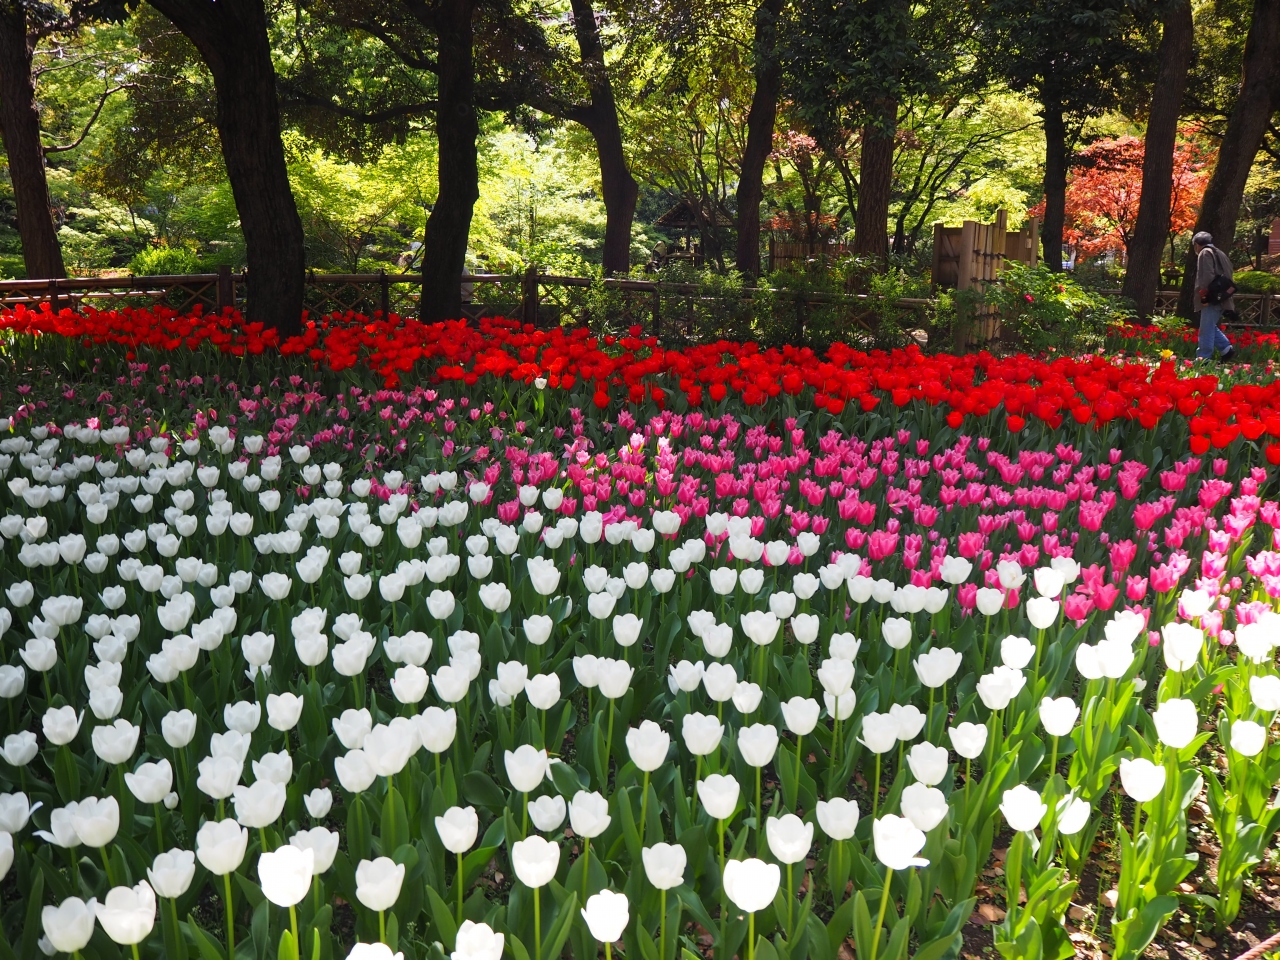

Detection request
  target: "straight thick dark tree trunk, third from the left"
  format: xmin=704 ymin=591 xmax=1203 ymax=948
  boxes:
xmin=421 ymin=0 xmax=480 ymax=321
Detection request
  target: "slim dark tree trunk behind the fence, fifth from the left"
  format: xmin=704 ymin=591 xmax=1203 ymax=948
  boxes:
xmin=735 ymin=0 xmax=783 ymax=276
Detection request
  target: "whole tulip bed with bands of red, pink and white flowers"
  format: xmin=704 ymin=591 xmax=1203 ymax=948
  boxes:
xmin=0 ymin=317 xmax=1280 ymax=960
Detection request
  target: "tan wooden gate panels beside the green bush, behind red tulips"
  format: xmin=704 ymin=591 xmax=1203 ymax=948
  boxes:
xmin=933 ymin=210 xmax=1039 ymax=349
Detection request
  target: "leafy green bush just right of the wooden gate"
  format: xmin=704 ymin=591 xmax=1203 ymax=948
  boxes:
xmin=983 ymin=264 xmax=1119 ymax=353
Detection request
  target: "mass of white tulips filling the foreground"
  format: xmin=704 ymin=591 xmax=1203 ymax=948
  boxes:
xmin=0 ymin=421 xmax=1280 ymax=960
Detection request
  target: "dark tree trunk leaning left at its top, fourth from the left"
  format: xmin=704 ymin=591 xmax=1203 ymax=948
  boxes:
xmin=572 ymin=0 xmax=640 ymax=275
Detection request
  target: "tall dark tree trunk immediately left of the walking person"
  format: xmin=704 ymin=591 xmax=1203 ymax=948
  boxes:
xmin=1123 ymin=0 xmax=1194 ymax=319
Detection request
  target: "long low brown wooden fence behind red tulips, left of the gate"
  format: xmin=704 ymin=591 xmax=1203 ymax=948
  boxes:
xmin=0 ymin=268 xmax=934 ymax=343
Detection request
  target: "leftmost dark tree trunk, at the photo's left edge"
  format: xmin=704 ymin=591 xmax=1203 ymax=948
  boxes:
xmin=0 ymin=0 xmax=67 ymax=280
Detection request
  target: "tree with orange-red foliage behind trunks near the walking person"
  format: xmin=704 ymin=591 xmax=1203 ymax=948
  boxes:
xmin=1030 ymin=129 xmax=1212 ymax=259
